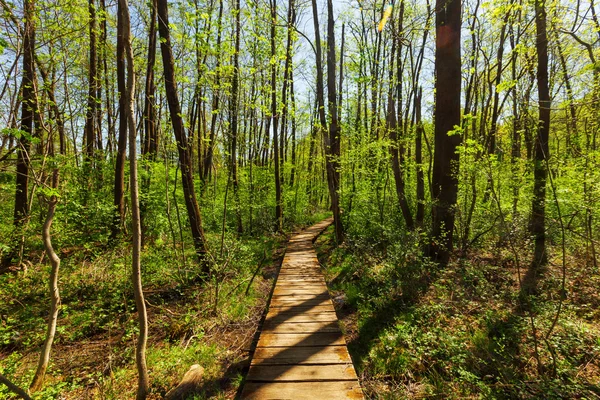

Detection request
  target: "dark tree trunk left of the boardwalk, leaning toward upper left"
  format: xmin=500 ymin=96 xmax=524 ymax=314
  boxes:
xmin=157 ymin=0 xmax=209 ymax=275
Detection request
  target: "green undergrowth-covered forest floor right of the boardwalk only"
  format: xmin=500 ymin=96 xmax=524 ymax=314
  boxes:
xmin=316 ymin=229 xmax=600 ymax=399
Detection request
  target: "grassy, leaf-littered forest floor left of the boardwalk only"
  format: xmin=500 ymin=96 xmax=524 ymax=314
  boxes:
xmin=0 ymin=228 xmax=292 ymax=400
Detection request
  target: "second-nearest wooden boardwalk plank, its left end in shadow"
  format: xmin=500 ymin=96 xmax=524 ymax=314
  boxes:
xmin=246 ymin=364 xmax=358 ymax=382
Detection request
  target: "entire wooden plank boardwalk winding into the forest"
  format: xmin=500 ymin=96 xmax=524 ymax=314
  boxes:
xmin=241 ymin=219 xmax=364 ymax=400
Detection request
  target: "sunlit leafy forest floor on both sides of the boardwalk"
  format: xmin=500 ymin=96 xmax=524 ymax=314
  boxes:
xmin=0 ymin=217 xmax=600 ymax=400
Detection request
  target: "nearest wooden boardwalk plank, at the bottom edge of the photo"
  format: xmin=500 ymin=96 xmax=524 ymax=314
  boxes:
xmin=241 ymin=381 xmax=364 ymax=400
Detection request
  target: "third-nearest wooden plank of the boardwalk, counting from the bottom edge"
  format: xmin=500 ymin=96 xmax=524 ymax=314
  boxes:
xmin=251 ymin=346 xmax=352 ymax=365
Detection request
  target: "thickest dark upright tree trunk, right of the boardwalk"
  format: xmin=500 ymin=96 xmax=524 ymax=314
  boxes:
xmin=430 ymin=0 xmax=461 ymax=265
